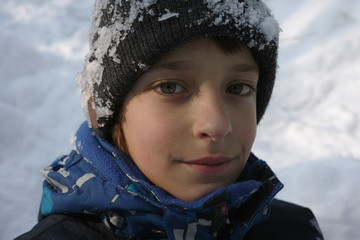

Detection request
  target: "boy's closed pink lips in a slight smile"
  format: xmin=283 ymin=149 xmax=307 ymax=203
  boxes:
xmin=183 ymin=155 xmax=233 ymax=174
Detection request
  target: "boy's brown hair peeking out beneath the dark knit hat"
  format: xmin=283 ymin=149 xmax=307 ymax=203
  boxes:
xmin=111 ymin=37 xmax=257 ymax=156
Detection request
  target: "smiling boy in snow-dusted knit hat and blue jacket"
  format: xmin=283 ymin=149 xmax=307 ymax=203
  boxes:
xmin=19 ymin=0 xmax=322 ymax=239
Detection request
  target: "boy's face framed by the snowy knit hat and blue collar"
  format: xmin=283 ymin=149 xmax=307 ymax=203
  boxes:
xmin=123 ymin=39 xmax=259 ymax=202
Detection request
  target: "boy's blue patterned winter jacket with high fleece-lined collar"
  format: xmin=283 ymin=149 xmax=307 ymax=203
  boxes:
xmin=19 ymin=123 xmax=322 ymax=240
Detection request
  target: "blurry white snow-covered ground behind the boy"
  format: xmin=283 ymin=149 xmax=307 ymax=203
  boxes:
xmin=0 ymin=0 xmax=360 ymax=240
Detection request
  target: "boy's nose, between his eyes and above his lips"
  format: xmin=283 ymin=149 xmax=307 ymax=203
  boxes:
xmin=193 ymin=90 xmax=233 ymax=142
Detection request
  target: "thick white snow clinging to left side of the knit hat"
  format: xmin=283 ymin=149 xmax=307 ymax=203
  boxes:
xmin=76 ymin=0 xmax=156 ymax=123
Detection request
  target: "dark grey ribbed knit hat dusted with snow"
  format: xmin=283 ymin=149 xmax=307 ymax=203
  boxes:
xmin=77 ymin=0 xmax=280 ymax=138
